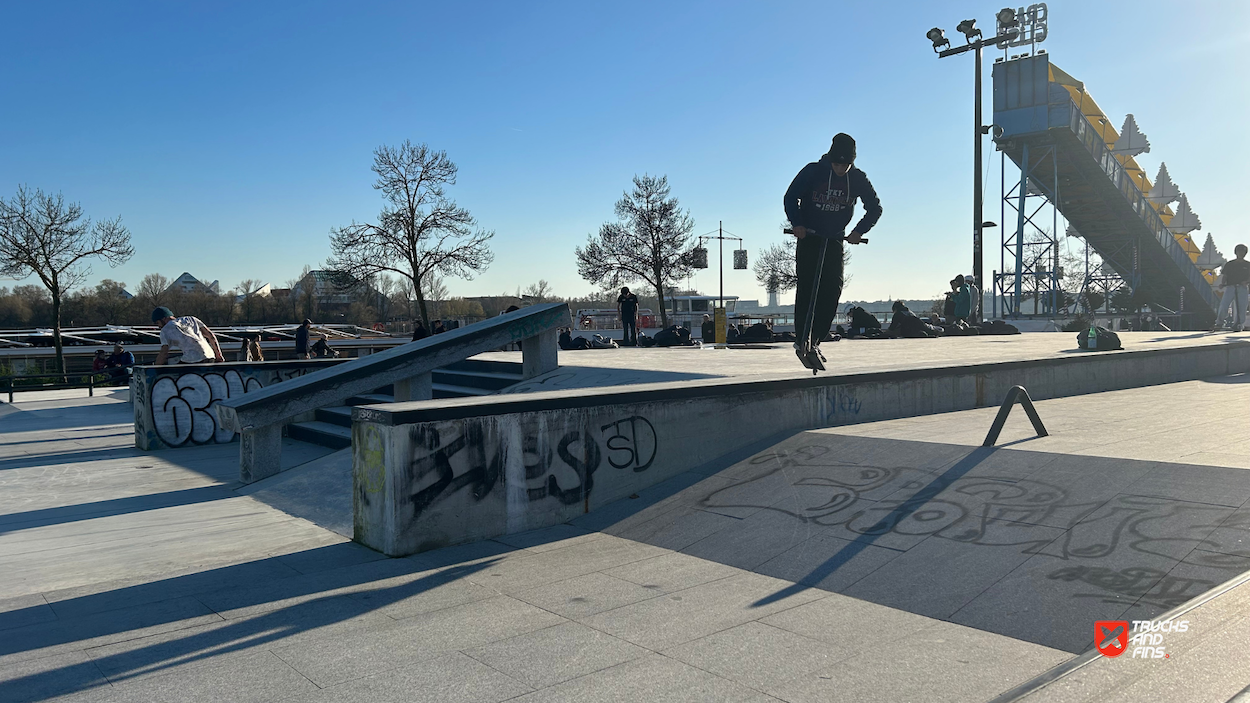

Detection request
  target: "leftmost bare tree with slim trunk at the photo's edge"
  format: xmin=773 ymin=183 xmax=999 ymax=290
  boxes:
xmin=0 ymin=186 xmax=135 ymax=372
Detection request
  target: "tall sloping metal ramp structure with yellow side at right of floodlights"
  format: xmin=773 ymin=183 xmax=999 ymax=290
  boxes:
xmin=994 ymin=54 xmax=1219 ymax=329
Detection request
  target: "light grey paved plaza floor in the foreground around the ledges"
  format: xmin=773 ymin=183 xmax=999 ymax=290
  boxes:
xmin=0 ymin=357 xmax=1250 ymax=703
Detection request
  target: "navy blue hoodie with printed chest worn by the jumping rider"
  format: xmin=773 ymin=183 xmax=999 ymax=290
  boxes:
xmin=785 ymin=155 xmax=881 ymax=236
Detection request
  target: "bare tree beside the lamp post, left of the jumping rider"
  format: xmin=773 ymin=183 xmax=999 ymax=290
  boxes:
xmin=576 ymin=175 xmax=695 ymax=328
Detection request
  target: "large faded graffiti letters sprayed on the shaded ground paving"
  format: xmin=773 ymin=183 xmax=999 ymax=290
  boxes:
xmin=699 ymin=444 xmax=1250 ymax=608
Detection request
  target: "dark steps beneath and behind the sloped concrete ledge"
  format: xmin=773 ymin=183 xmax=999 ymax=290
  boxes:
xmin=286 ymin=359 xmax=523 ymax=449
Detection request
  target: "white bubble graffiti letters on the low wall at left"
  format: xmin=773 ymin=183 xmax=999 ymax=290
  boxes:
xmin=150 ymin=369 xmax=261 ymax=447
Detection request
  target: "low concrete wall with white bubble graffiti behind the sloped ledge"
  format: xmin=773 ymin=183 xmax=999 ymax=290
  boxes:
xmin=130 ymin=359 xmax=350 ymax=450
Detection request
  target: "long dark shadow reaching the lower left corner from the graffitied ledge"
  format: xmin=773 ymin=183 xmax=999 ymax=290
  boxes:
xmin=0 ymin=535 xmax=513 ymax=700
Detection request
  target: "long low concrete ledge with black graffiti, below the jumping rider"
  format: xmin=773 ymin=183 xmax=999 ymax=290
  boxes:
xmin=353 ymin=343 xmax=1250 ymax=555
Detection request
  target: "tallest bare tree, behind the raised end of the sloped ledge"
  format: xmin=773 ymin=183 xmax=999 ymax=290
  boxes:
xmin=329 ymin=140 xmax=495 ymax=325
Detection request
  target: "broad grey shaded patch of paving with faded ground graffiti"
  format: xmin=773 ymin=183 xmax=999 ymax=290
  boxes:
xmin=573 ymin=432 xmax=1250 ymax=652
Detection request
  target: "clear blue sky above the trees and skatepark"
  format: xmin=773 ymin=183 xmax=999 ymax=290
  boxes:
xmin=0 ymin=0 xmax=1250 ymax=299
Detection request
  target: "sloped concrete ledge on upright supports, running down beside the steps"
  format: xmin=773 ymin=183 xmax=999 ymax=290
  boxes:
xmin=216 ymin=303 xmax=570 ymax=483
